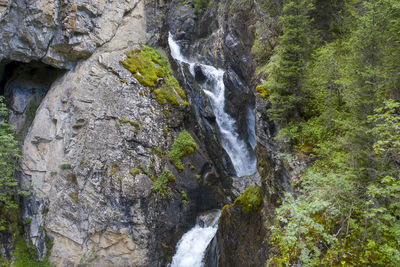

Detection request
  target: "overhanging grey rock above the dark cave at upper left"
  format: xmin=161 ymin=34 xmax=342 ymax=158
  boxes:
xmin=0 ymin=0 xmax=141 ymax=69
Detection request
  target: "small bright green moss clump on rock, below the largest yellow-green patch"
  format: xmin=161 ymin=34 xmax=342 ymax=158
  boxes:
xmin=168 ymin=130 xmax=197 ymax=171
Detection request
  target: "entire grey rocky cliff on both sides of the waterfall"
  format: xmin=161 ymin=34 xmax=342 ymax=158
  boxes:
xmin=0 ymin=0 xmax=290 ymax=266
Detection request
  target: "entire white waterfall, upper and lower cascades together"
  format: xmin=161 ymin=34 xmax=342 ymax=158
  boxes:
xmin=168 ymin=33 xmax=257 ymax=267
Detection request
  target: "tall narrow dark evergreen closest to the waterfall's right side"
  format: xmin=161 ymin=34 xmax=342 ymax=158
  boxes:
xmin=264 ymin=0 xmax=313 ymax=126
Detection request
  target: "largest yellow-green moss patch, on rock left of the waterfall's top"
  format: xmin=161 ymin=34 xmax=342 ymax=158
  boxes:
xmin=121 ymin=45 xmax=187 ymax=106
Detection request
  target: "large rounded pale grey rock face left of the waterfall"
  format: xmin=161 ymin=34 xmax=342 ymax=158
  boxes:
xmin=14 ymin=1 xmax=215 ymax=266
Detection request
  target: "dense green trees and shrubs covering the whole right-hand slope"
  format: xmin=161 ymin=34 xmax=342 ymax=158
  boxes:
xmin=259 ymin=0 xmax=400 ymax=266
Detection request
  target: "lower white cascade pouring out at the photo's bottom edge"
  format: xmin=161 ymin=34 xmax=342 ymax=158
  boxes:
xmin=170 ymin=211 xmax=220 ymax=267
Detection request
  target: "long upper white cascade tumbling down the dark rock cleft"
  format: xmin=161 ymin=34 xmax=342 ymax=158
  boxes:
xmin=168 ymin=34 xmax=257 ymax=177
